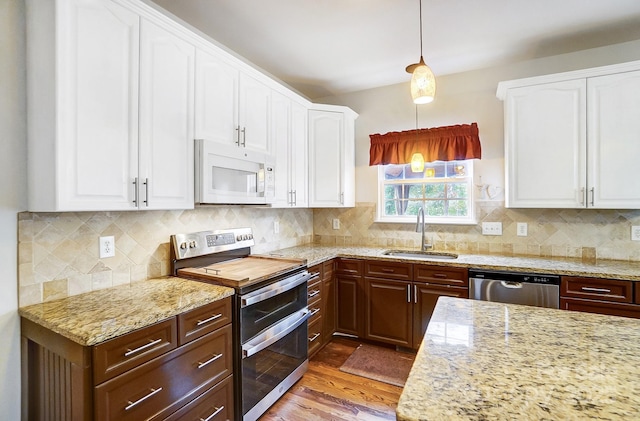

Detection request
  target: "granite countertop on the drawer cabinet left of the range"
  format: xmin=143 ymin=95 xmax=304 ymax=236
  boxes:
xmin=18 ymin=277 xmax=234 ymax=346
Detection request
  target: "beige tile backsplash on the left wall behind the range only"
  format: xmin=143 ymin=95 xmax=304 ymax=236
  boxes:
xmin=18 ymin=206 xmax=313 ymax=306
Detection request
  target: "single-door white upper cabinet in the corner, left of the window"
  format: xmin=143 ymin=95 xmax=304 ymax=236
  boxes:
xmin=309 ymin=105 xmax=357 ymax=208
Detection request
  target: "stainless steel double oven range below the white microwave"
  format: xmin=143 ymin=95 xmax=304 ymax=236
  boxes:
xmin=170 ymin=228 xmax=311 ymax=421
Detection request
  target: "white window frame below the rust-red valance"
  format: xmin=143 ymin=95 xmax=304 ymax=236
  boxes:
xmin=375 ymin=159 xmax=477 ymax=225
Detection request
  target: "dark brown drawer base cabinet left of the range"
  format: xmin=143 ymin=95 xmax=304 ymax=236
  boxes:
xmin=21 ymin=298 xmax=234 ymax=421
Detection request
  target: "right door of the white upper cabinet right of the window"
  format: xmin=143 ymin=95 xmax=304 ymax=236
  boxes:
xmin=587 ymin=71 xmax=640 ymax=209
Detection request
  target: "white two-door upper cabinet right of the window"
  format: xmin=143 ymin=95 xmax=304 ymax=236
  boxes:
xmin=497 ymin=62 xmax=640 ymax=209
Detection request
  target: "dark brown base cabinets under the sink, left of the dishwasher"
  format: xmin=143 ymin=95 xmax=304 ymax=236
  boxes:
xmin=336 ymin=259 xmax=469 ymax=348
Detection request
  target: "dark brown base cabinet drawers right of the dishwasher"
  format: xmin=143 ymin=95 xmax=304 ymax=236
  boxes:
xmin=560 ymin=276 xmax=640 ymax=319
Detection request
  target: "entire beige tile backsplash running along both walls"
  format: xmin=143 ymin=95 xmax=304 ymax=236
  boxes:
xmin=18 ymin=201 xmax=640 ymax=306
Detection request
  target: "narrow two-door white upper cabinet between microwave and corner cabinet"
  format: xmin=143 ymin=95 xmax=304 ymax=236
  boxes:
xmin=271 ymin=92 xmax=309 ymax=208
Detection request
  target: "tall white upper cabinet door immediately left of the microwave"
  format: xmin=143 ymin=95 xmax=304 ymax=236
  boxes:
xmin=138 ymin=20 xmax=195 ymax=209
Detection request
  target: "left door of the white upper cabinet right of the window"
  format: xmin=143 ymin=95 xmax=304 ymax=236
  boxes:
xmin=505 ymin=79 xmax=586 ymax=208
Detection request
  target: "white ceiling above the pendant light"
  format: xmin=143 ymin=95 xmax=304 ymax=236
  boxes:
xmin=151 ymin=0 xmax=640 ymax=99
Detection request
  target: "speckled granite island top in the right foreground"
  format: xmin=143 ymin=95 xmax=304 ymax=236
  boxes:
xmin=396 ymin=297 xmax=640 ymax=421
